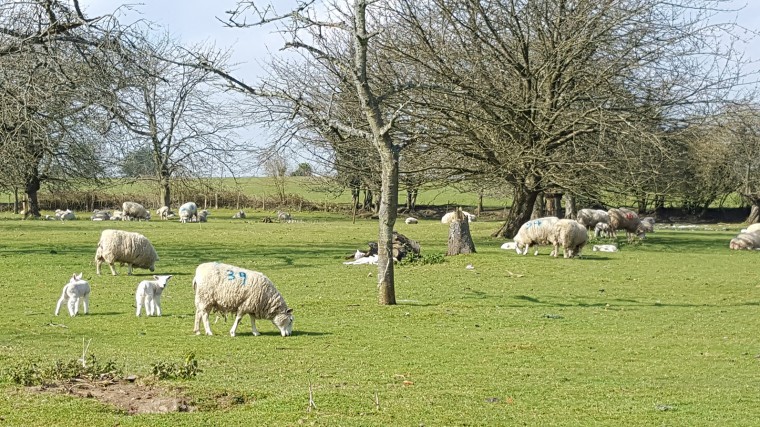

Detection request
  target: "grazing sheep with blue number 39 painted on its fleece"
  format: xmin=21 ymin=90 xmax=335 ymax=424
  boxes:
xmin=193 ymin=262 xmax=293 ymax=337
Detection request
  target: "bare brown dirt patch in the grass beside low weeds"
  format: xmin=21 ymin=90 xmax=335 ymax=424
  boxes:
xmin=30 ymin=379 xmax=197 ymax=414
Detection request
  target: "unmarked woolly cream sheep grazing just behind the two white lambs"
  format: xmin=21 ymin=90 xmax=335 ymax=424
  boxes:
xmin=95 ymin=230 xmax=158 ymax=276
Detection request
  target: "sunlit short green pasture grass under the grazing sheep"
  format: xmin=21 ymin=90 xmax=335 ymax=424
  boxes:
xmin=0 ymin=211 xmax=760 ymax=426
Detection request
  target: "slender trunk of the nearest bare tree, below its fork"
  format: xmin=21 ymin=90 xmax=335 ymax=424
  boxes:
xmin=377 ymin=149 xmax=399 ymax=305
